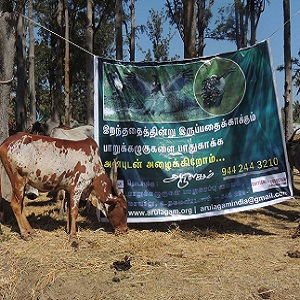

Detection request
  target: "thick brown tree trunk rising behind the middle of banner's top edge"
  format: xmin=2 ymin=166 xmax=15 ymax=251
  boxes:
xmin=184 ymin=0 xmax=197 ymax=58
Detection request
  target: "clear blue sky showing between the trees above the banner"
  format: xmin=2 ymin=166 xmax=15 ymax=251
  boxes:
xmin=135 ymin=0 xmax=300 ymax=103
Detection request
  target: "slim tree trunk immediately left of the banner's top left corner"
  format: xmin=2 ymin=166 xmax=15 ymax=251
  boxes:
xmin=85 ymin=0 xmax=94 ymax=125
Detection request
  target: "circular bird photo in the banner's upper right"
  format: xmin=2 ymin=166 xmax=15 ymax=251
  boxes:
xmin=194 ymin=57 xmax=246 ymax=115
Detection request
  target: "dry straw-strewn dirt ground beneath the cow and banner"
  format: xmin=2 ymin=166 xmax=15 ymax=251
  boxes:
xmin=0 ymin=175 xmax=300 ymax=300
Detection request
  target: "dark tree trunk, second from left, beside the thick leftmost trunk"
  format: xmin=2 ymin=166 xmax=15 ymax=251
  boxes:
xmin=15 ymin=9 xmax=27 ymax=131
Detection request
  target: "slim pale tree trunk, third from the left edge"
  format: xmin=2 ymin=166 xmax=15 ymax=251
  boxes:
xmin=28 ymin=0 xmax=36 ymax=125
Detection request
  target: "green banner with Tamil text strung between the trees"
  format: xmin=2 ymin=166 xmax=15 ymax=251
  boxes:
xmin=95 ymin=41 xmax=292 ymax=222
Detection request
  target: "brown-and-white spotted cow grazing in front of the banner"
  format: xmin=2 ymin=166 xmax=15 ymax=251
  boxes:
xmin=0 ymin=132 xmax=128 ymax=246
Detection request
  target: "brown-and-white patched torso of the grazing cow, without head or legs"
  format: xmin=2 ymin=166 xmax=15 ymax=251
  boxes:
xmin=0 ymin=133 xmax=103 ymax=191
